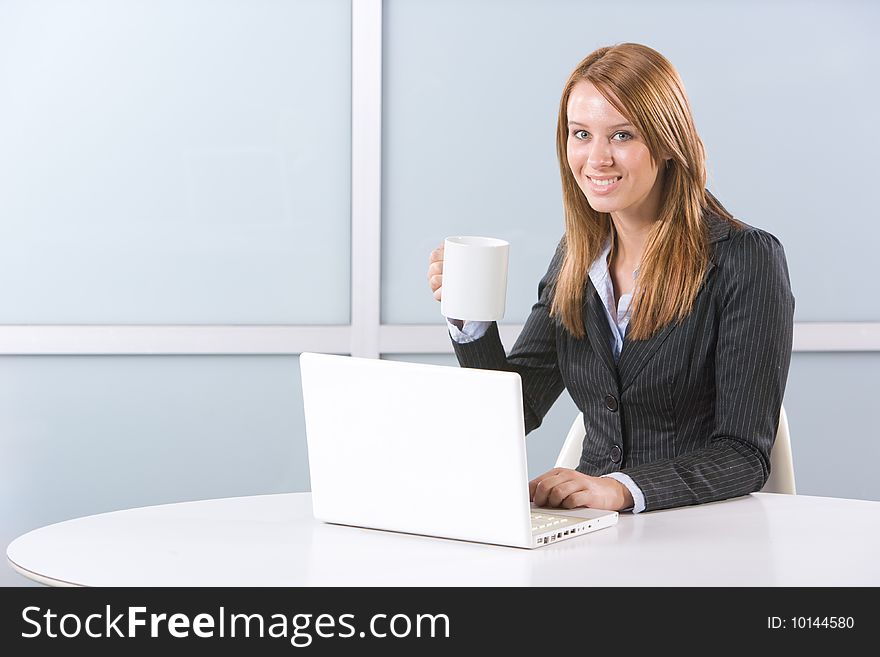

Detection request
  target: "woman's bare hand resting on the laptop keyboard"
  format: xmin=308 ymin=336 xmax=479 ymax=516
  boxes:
xmin=529 ymin=468 xmax=633 ymax=511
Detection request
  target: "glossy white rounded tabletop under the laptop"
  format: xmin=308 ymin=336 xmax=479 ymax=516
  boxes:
xmin=7 ymin=493 xmax=880 ymax=586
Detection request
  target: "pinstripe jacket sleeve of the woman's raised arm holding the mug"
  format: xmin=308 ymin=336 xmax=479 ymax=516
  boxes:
xmin=453 ymin=242 xmax=564 ymax=433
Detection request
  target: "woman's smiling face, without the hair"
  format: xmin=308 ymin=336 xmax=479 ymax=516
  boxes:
xmin=567 ymin=81 xmax=662 ymax=221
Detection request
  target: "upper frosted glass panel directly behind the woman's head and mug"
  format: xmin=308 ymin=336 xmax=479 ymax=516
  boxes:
xmin=382 ymin=0 xmax=880 ymax=323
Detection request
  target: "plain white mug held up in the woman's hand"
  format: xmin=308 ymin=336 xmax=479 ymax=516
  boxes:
xmin=440 ymin=236 xmax=510 ymax=321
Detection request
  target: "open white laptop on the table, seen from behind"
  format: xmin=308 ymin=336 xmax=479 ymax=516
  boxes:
xmin=300 ymin=353 xmax=618 ymax=548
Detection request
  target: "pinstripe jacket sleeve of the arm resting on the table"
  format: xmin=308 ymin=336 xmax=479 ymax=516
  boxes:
xmin=623 ymin=230 xmax=794 ymax=511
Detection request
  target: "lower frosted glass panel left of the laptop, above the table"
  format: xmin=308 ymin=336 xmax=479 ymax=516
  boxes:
xmin=0 ymin=356 xmax=310 ymax=585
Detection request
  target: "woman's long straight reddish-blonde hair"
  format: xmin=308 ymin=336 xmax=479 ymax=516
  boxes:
xmin=550 ymin=43 xmax=741 ymax=340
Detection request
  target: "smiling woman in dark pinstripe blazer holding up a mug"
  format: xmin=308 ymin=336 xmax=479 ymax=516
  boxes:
xmin=428 ymin=43 xmax=794 ymax=513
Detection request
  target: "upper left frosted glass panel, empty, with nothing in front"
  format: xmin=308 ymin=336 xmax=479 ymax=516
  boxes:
xmin=0 ymin=0 xmax=351 ymax=324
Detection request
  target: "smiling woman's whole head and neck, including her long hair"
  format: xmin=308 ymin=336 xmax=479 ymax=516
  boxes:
xmin=553 ymin=43 xmax=741 ymax=339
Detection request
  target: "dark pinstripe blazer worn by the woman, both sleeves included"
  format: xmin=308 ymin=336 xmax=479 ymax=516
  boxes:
xmin=453 ymin=213 xmax=794 ymax=511
